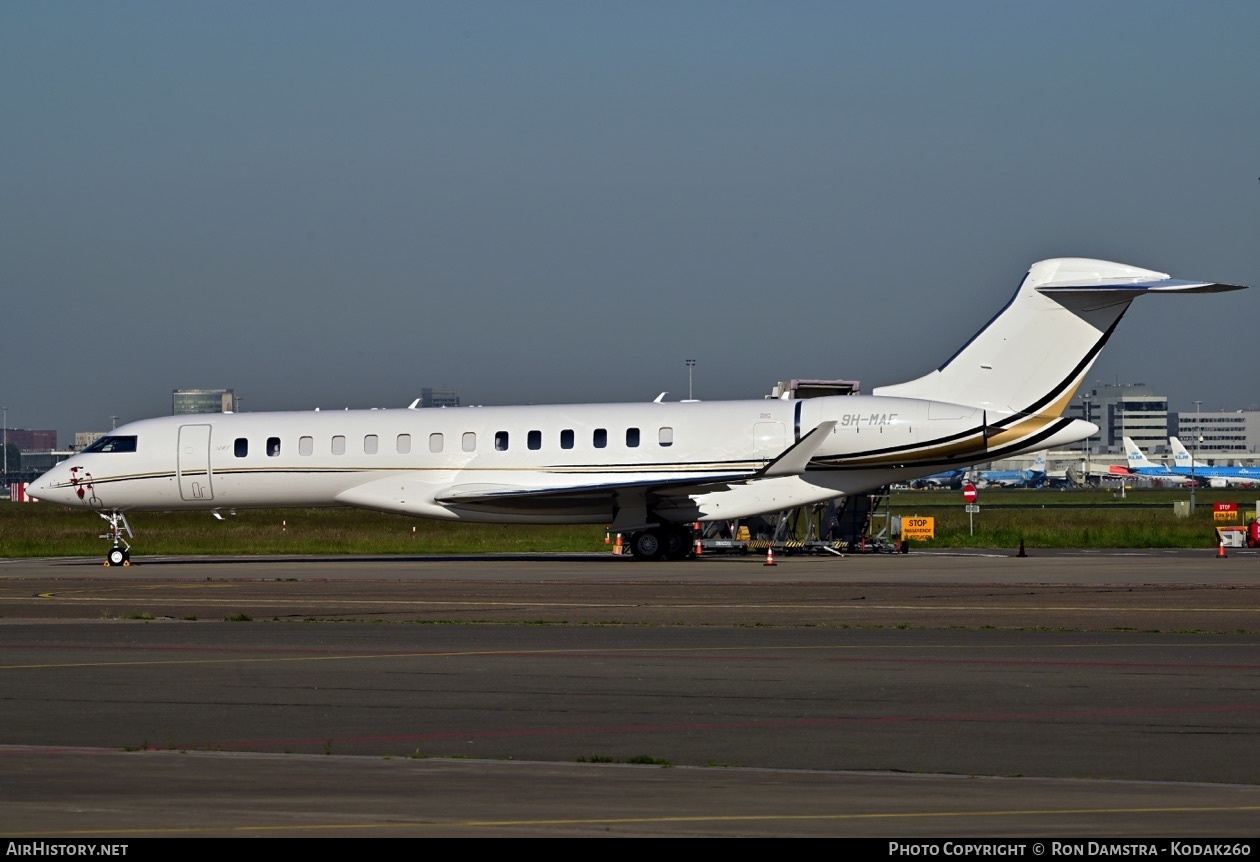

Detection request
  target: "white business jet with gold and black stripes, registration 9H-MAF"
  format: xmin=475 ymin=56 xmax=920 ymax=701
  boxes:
xmin=28 ymin=258 xmax=1237 ymax=565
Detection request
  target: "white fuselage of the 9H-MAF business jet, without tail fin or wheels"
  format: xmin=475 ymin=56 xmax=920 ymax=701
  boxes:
xmin=37 ymin=396 xmax=1089 ymax=523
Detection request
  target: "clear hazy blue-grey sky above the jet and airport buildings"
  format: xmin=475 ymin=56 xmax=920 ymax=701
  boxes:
xmin=0 ymin=0 xmax=1260 ymax=441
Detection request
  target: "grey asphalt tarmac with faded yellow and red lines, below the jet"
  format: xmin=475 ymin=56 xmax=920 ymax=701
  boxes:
xmin=0 ymin=549 xmax=1260 ymax=842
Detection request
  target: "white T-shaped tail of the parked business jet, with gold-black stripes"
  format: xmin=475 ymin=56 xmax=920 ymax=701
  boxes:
xmin=874 ymin=257 xmax=1242 ymax=431
